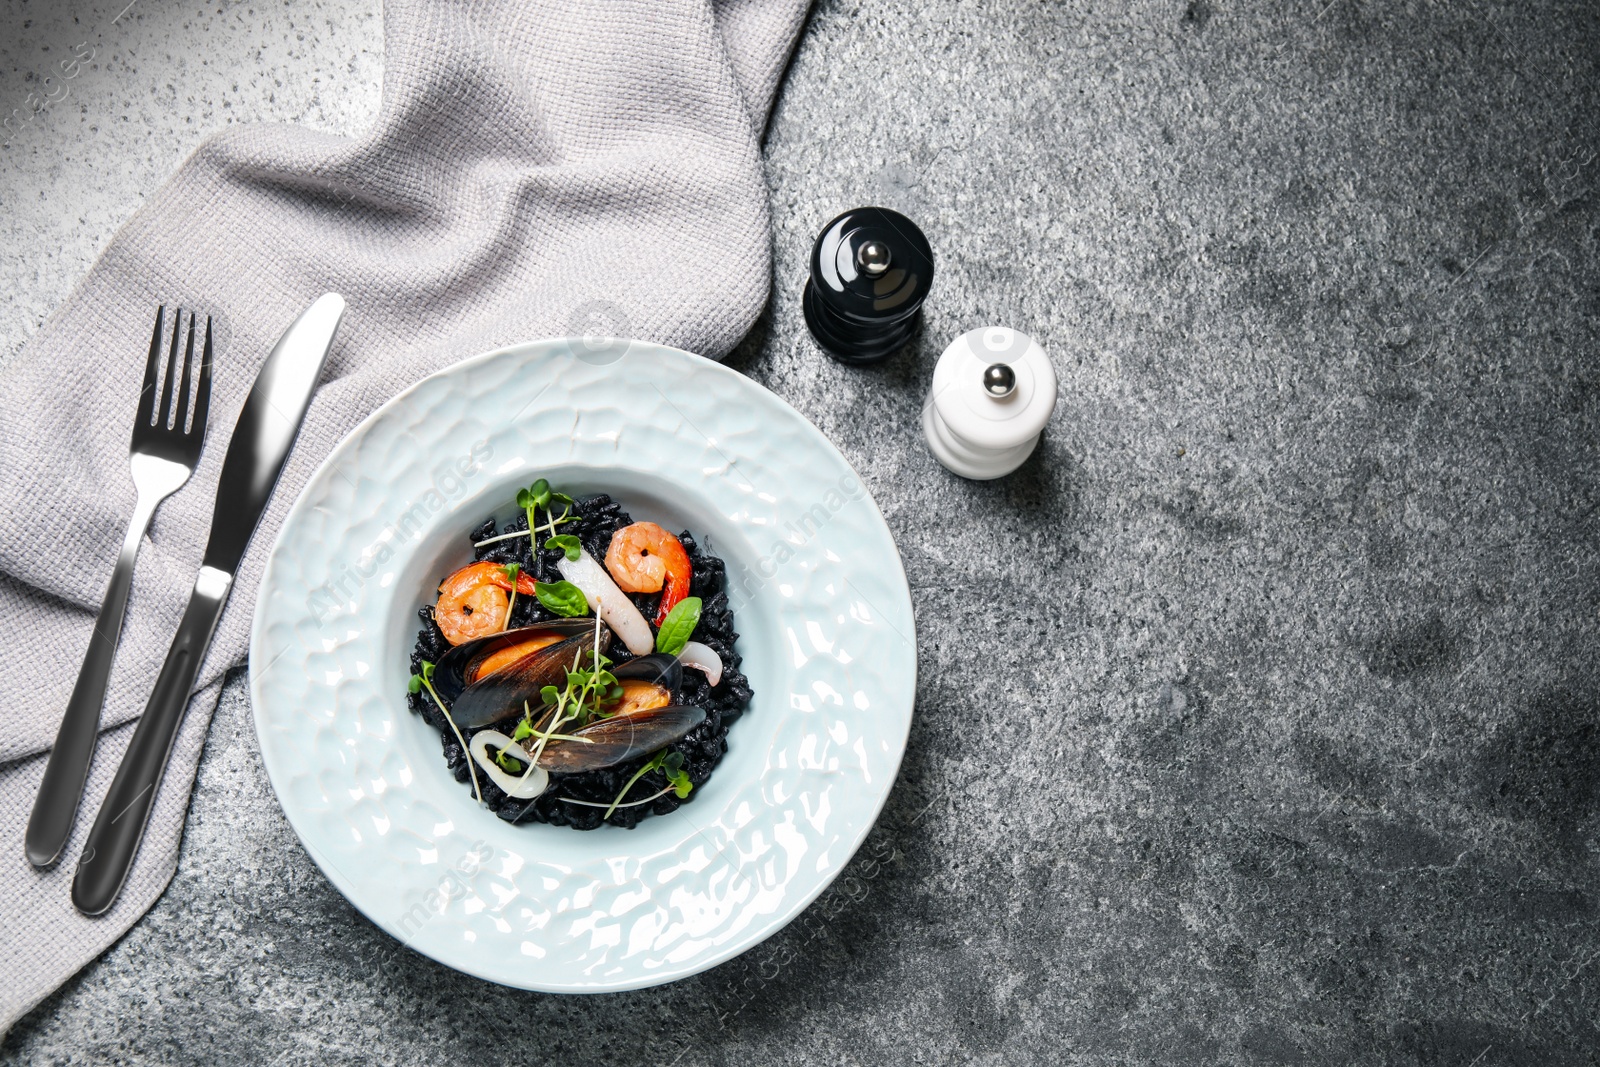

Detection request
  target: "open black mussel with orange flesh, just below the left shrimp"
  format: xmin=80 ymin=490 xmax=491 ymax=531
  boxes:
xmin=434 ymin=619 xmax=611 ymax=729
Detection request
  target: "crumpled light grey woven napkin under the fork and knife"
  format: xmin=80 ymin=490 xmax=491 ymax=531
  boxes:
xmin=0 ymin=0 xmax=806 ymax=1033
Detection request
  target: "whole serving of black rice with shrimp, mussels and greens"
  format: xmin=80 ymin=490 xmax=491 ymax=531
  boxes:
xmin=406 ymin=478 xmax=750 ymax=830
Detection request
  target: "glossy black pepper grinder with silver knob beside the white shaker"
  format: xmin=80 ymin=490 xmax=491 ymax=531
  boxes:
xmin=802 ymin=208 xmax=933 ymax=363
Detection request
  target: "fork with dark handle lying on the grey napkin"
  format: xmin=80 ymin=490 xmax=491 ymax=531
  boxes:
xmin=27 ymin=304 xmax=211 ymax=867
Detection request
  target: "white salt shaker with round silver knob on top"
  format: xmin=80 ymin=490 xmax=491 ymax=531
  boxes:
xmin=922 ymin=326 xmax=1056 ymax=480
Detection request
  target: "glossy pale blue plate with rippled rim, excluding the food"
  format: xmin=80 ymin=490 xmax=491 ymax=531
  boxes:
xmin=250 ymin=341 xmax=917 ymax=992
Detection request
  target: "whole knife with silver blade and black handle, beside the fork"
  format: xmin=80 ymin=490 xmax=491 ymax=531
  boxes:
xmin=72 ymin=293 xmax=344 ymax=915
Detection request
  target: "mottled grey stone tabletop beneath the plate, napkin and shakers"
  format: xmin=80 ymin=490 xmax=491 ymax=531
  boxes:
xmin=0 ymin=0 xmax=1600 ymax=1067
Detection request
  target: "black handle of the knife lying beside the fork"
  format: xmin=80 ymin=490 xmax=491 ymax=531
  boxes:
xmin=72 ymin=566 xmax=232 ymax=915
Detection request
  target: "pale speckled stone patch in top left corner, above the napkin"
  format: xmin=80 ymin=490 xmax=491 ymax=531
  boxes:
xmin=0 ymin=0 xmax=382 ymax=358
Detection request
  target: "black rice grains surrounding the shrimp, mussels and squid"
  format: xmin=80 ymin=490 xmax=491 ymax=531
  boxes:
xmin=406 ymin=493 xmax=750 ymax=830
